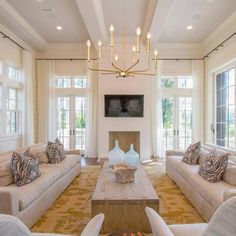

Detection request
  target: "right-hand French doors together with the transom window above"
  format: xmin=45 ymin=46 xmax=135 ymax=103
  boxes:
xmin=161 ymin=75 xmax=193 ymax=150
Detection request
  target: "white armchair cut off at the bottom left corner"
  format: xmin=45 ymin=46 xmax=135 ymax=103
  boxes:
xmin=0 ymin=213 xmax=104 ymax=236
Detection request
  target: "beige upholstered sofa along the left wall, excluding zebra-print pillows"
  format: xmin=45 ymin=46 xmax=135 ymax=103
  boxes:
xmin=0 ymin=144 xmax=81 ymax=227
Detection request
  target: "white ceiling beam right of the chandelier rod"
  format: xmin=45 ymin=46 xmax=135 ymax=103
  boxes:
xmin=143 ymin=0 xmax=175 ymax=43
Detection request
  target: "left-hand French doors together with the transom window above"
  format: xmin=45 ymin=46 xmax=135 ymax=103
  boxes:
xmin=55 ymin=76 xmax=87 ymax=150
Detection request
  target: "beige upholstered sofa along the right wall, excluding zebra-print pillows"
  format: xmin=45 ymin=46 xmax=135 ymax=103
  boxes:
xmin=166 ymin=145 xmax=236 ymax=221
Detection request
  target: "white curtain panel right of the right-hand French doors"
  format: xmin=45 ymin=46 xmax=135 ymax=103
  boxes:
xmin=192 ymin=60 xmax=204 ymax=143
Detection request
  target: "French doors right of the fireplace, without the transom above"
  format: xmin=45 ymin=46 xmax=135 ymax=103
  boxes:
xmin=162 ymin=95 xmax=192 ymax=150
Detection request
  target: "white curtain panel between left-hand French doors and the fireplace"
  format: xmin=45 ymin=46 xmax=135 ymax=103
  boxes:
xmin=85 ymin=61 xmax=98 ymax=157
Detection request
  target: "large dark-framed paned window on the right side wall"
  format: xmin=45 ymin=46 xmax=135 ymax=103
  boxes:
xmin=216 ymin=68 xmax=236 ymax=147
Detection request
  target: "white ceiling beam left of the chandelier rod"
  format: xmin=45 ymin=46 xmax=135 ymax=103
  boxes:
xmin=76 ymin=0 xmax=107 ymax=48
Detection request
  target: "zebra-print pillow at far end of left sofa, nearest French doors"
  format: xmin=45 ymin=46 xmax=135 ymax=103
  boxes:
xmin=46 ymin=138 xmax=65 ymax=164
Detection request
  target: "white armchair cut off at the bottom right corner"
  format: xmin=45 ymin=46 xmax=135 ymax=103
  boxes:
xmin=145 ymin=197 xmax=236 ymax=236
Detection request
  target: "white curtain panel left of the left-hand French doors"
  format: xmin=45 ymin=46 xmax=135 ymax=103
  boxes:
xmin=36 ymin=60 xmax=56 ymax=143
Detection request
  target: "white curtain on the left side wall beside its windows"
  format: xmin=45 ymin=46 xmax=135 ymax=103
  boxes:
xmin=22 ymin=50 xmax=34 ymax=146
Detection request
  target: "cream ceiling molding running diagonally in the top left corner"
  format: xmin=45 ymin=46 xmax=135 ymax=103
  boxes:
xmin=0 ymin=0 xmax=47 ymax=51
